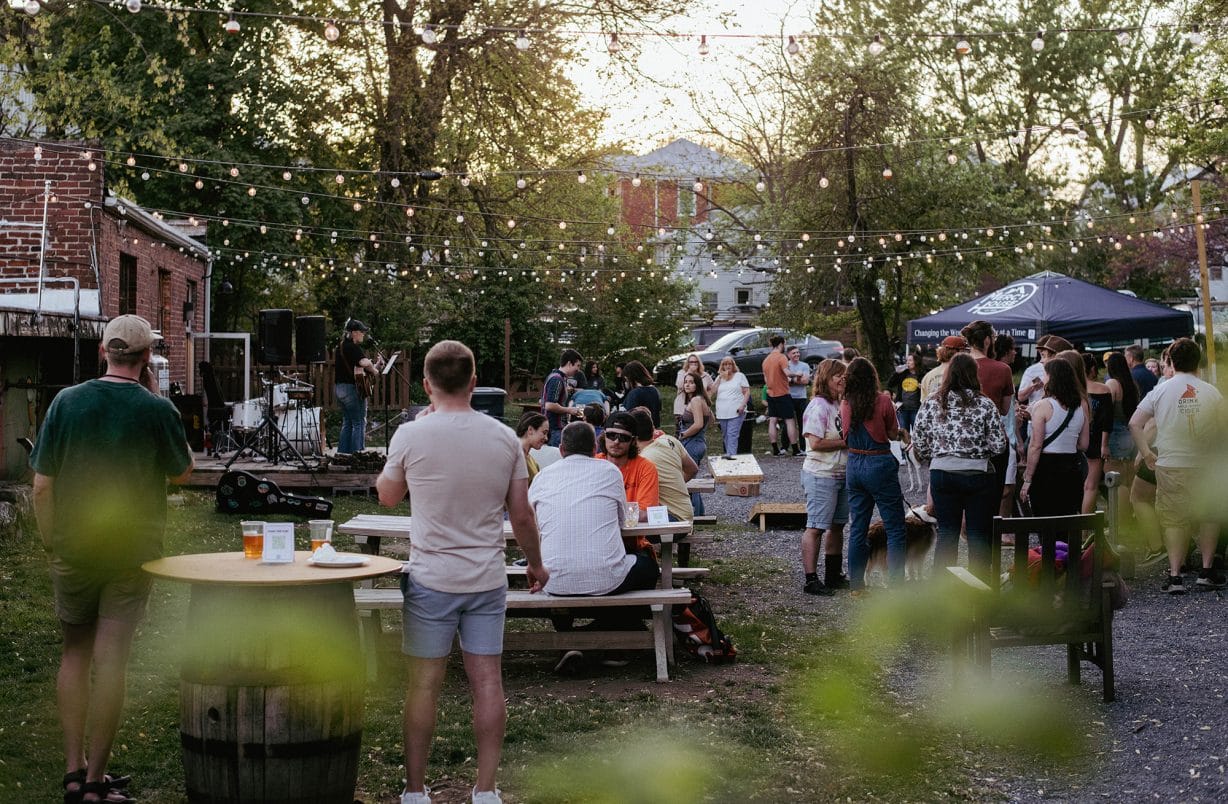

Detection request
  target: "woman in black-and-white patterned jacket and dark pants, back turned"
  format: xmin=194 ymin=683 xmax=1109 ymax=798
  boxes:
xmin=912 ymin=355 xmax=1007 ymax=578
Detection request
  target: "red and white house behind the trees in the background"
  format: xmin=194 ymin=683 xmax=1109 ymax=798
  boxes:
xmin=608 ymin=140 xmax=771 ymax=324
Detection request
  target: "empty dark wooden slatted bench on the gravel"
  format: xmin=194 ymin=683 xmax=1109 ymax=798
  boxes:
xmin=947 ymin=511 xmax=1115 ymax=702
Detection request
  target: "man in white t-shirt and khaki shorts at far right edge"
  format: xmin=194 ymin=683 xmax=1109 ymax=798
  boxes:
xmin=1130 ymin=338 xmax=1228 ymax=594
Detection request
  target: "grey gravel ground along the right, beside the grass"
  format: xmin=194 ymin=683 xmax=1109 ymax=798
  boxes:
xmin=701 ymin=455 xmax=1228 ymax=802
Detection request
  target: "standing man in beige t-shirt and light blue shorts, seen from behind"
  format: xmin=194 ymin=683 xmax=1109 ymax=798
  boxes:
xmin=376 ymin=340 xmax=550 ymax=804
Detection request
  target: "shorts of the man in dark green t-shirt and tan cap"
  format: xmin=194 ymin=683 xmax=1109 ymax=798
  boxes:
xmin=52 ymin=556 xmax=154 ymax=625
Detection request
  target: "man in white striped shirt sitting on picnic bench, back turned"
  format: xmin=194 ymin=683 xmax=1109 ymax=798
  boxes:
xmin=529 ymin=422 xmax=659 ymax=594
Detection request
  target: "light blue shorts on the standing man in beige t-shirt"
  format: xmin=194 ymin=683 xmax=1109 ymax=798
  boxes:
xmin=400 ymin=573 xmax=507 ymax=659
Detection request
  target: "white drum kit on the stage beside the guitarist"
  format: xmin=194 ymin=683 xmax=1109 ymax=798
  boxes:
xmin=226 ymin=371 xmax=324 ymax=466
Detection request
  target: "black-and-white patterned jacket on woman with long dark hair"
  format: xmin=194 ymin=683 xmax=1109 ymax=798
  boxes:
xmin=912 ymin=392 xmax=1006 ymax=460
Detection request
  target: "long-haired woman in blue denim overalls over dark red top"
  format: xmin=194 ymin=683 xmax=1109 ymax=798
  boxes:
xmin=840 ymin=357 xmax=905 ymax=595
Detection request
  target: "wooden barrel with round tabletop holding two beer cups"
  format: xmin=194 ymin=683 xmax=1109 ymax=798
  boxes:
xmin=145 ymin=552 xmax=400 ymax=804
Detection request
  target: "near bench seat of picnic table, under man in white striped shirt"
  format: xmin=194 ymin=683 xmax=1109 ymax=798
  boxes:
xmin=354 ymin=588 xmax=691 ymax=681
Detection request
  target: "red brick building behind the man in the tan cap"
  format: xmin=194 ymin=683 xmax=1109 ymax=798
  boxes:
xmin=0 ymin=139 xmax=210 ymax=479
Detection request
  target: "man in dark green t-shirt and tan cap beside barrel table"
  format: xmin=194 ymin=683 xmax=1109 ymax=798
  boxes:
xmin=29 ymin=315 xmax=193 ymax=800
